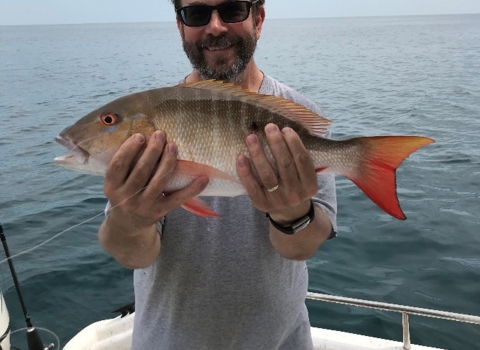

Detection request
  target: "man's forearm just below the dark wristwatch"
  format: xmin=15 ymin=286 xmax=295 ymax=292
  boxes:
xmin=269 ymin=206 xmax=332 ymax=260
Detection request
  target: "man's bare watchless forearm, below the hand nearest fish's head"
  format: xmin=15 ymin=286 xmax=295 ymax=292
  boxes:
xmin=98 ymin=212 xmax=161 ymax=269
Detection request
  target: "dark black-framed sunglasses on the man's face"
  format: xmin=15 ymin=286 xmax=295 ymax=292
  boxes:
xmin=176 ymin=0 xmax=258 ymax=27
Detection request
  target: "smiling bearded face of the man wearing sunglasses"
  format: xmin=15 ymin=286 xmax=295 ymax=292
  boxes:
xmin=177 ymin=0 xmax=263 ymax=82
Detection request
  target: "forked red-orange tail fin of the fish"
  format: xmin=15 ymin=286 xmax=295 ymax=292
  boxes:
xmin=345 ymin=136 xmax=435 ymax=220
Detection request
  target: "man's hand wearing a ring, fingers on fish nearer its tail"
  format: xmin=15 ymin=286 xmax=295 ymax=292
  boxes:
xmin=237 ymin=124 xmax=318 ymax=224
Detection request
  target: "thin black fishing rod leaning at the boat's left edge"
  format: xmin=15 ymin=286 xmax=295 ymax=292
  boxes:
xmin=0 ymin=224 xmax=54 ymax=350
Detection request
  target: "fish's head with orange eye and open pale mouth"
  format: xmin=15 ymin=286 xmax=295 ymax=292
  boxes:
xmin=54 ymin=96 xmax=155 ymax=175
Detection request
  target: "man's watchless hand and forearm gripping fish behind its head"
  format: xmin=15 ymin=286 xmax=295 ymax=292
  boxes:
xmin=98 ymin=131 xmax=208 ymax=269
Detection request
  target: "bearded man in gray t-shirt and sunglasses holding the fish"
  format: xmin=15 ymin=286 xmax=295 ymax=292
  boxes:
xmin=99 ymin=0 xmax=336 ymax=350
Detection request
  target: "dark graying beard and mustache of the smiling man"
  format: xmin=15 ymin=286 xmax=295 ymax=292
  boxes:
xmin=182 ymin=31 xmax=257 ymax=82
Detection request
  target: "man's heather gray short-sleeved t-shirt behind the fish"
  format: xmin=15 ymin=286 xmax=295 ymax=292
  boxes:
xmin=132 ymin=75 xmax=336 ymax=350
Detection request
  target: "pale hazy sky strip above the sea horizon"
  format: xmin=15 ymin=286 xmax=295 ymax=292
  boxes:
xmin=0 ymin=0 xmax=480 ymax=25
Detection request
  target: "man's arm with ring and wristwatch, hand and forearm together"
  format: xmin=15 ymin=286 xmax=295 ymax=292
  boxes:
xmin=237 ymin=124 xmax=332 ymax=260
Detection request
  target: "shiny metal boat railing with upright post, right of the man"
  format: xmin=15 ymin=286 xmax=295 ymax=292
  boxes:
xmin=307 ymin=292 xmax=480 ymax=350
